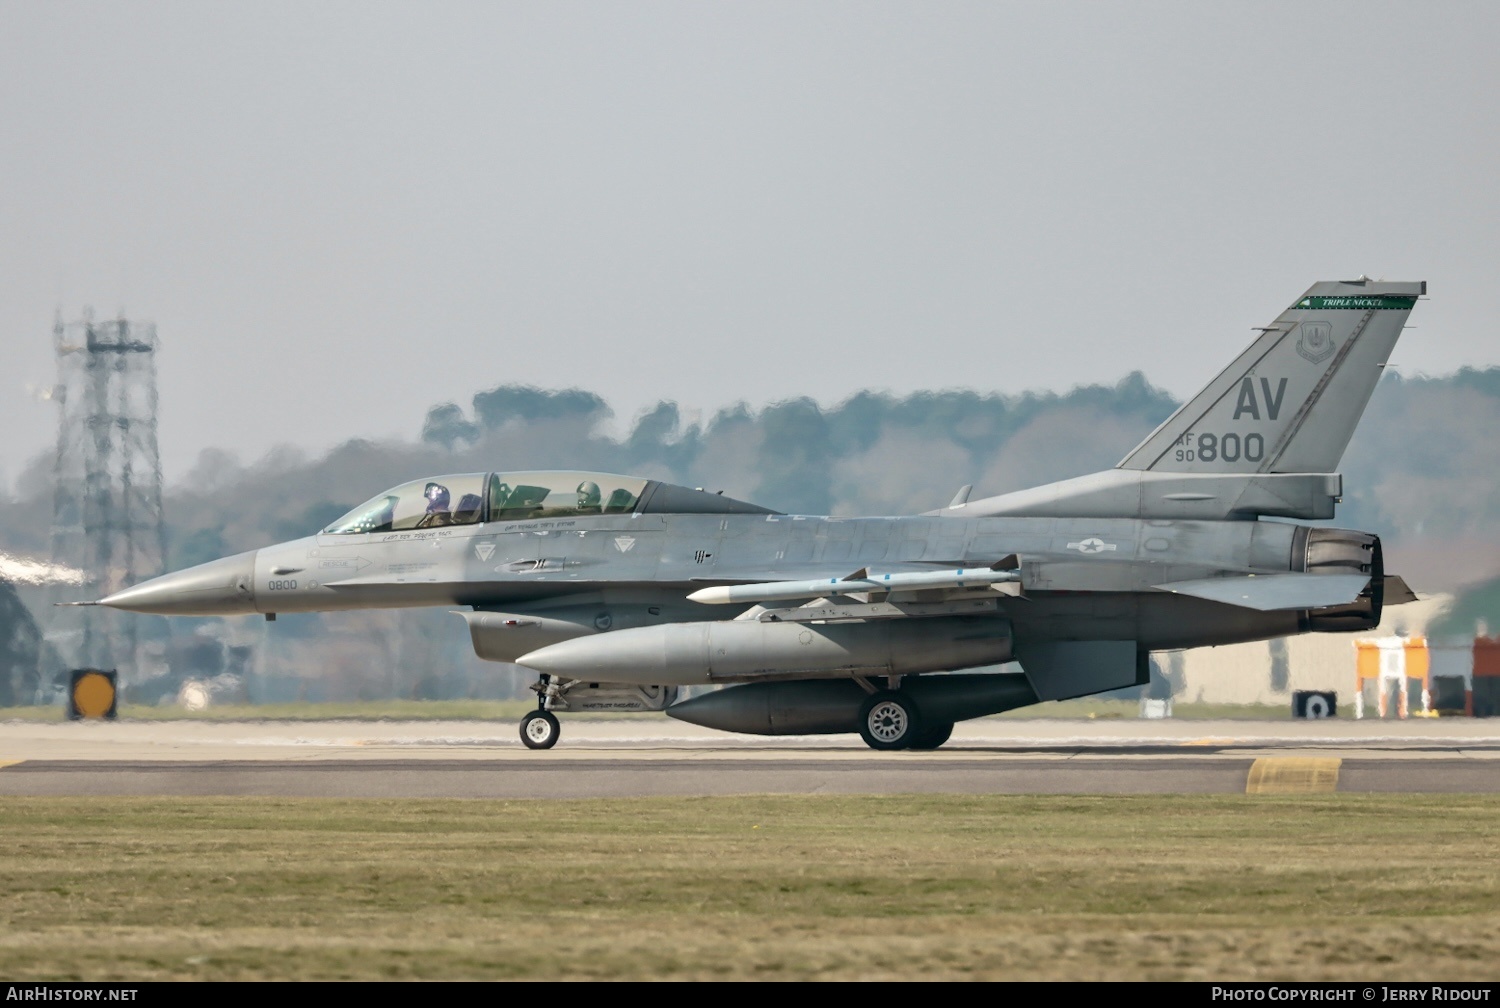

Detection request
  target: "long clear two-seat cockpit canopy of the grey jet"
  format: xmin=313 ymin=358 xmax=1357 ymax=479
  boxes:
xmin=323 ymin=470 xmax=774 ymax=536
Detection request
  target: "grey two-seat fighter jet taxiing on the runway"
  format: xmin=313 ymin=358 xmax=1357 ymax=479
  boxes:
xmin=98 ymin=278 xmax=1427 ymax=750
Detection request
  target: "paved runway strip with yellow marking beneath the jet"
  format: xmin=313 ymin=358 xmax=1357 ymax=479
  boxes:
xmin=0 ymin=717 xmax=1500 ymax=800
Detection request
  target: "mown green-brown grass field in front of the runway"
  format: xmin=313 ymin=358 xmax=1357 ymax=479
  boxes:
xmin=0 ymin=795 xmax=1500 ymax=980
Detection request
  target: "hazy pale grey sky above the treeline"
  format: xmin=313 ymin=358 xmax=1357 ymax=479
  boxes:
xmin=0 ymin=0 xmax=1500 ymax=489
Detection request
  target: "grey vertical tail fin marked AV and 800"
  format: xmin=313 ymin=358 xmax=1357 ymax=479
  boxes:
xmin=1116 ymin=278 xmax=1427 ymax=473
